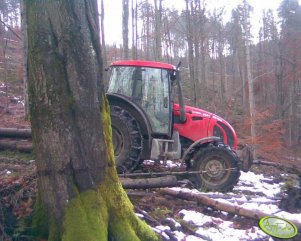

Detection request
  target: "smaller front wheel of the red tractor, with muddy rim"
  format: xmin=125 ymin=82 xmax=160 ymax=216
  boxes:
xmin=190 ymin=146 xmax=240 ymax=192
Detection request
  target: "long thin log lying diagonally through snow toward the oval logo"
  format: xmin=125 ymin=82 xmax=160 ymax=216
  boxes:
xmin=160 ymin=188 xmax=301 ymax=228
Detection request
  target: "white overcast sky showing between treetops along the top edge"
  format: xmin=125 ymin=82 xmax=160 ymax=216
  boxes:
xmin=104 ymin=0 xmax=300 ymax=44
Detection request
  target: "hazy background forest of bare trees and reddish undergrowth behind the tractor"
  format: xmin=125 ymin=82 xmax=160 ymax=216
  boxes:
xmin=0 ymin=0 xmax=301 ymax=169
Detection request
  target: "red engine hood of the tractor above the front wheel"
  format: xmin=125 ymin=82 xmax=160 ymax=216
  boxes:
xmin=173 ymin=104 xmax=238 ymax=149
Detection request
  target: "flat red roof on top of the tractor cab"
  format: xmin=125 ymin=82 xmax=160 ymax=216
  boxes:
xmin=111 ymin=60 xmax=176 ymax=70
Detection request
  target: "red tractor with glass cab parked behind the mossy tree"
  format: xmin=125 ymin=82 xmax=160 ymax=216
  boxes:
xmin=107 ymin=60 xmax=251 ymax=191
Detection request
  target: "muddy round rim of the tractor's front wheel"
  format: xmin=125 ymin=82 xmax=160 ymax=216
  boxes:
xmin=200 ymin=158 xmax=230 ymax=185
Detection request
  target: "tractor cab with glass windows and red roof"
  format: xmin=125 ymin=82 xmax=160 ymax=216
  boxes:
xmin=107 ymin=61 xmax=175 ymax=137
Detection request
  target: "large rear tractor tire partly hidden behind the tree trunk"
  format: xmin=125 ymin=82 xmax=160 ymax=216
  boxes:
xmin=111 ymin=106 xmax=143 ymax=173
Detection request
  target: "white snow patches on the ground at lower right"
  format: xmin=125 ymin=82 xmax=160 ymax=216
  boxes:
xmin=148 ymin=172 xmax=301 ymax=241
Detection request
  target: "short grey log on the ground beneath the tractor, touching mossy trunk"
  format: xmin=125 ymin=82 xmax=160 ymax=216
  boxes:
xmin=120 ymin=176 xmax=179 ymax=189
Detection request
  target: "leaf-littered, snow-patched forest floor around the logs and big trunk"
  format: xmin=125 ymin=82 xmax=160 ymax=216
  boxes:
xmin=0 ymin=97 xmax=301 ymax=241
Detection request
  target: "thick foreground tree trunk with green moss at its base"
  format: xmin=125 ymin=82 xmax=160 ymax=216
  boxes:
xmin=25 ymin=0 xmax=158 ymax=241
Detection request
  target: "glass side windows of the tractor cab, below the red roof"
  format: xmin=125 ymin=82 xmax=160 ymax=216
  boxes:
xmin=108 ymin=66 xmax=170 ymax=134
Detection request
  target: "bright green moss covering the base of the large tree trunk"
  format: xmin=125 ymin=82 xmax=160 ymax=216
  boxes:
xmin=62 ymin=179 xmax=159 ymax=241
